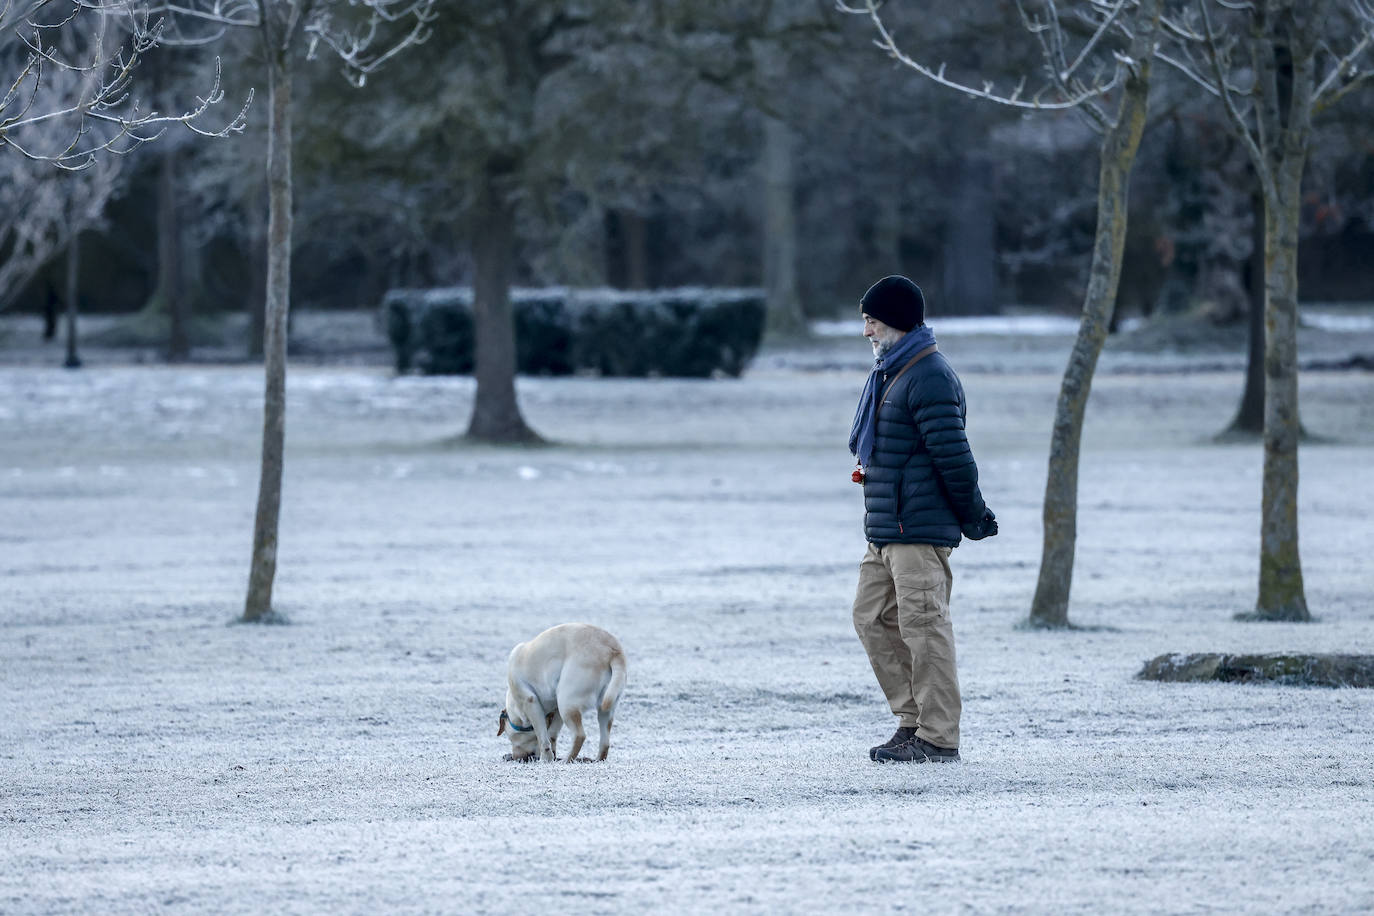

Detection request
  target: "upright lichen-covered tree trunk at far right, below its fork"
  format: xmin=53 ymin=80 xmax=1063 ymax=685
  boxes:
xmin=1245 ymin=164 xmax=1312 ymax=621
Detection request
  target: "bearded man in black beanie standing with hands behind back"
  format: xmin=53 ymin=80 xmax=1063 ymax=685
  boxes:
xmin=849 ymin=276 xmax=998 ymax=764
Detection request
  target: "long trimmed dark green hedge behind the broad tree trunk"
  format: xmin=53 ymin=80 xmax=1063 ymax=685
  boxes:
xmin=382 ymin=287 xmax=765 ymax=378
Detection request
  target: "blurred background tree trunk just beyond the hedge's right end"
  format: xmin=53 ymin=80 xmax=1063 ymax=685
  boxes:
xmin=761 ymin=115 xmax=802 ymax=338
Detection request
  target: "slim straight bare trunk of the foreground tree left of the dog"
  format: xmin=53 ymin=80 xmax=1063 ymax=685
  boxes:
xmin=243 ymin=57 xmax=291 ymax=622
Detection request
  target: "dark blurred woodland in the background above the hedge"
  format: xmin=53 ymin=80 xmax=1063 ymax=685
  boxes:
xmin=11 ymin=0 xmax=1374 ymax=329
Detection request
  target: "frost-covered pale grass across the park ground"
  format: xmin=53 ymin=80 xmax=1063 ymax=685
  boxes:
xmin=0 ymin=313 xmax=1374 ymax=913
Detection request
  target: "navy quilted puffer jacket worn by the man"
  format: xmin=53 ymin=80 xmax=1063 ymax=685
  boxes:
xmin=863 ymin=352 xmax=991 ymax=547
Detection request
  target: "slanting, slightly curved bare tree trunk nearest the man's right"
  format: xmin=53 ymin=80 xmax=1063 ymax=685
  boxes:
xmin=1029 ymin=0 xmax=1160 ymax=628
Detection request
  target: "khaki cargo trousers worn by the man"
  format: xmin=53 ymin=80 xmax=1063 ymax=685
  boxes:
xmin=855 ymin=544 xmax=962 ymax=747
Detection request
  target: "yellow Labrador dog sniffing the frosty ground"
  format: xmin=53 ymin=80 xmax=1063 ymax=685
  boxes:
xmin=496 ymin=623 xmax=625 ymax=764
